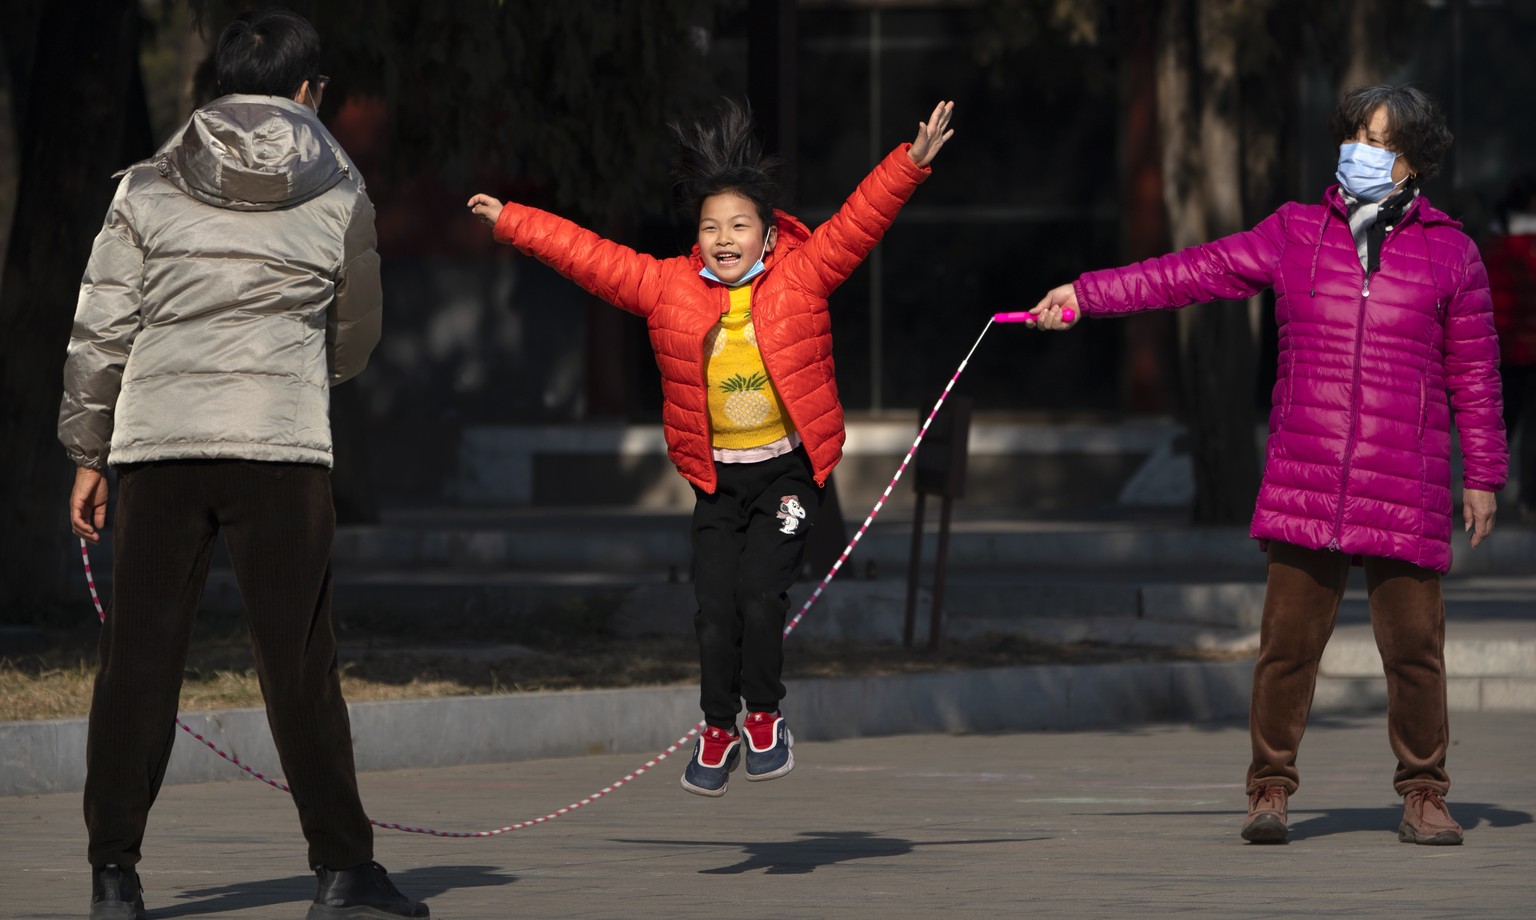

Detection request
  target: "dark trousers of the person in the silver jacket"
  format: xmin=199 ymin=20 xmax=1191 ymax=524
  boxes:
xmin=84 ymin=461 xmax=373 ymax=869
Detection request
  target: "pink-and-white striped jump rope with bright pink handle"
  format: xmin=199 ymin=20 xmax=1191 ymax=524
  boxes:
xmin=80 ymin=309 xmax=1075 ymax=837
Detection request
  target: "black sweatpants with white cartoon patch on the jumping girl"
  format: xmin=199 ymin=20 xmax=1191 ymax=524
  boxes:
xmin=693 ymin=447 xmax=823 ymax=728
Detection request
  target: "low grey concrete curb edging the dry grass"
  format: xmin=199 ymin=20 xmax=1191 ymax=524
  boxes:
xmin=0 ymin=662 xmax=1252 ymax=796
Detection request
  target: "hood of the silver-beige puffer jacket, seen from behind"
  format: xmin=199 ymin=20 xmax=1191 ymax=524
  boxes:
xmin=151 ymin=95 xmax=352 ymax=210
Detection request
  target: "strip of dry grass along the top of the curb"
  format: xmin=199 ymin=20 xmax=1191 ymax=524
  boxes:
xmin=0 ymin=602 xmax=1243 ymax=722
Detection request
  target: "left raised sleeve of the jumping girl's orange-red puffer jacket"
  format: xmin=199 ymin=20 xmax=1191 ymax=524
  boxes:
xmin=493 ymin=201 xmax=662 ymax=316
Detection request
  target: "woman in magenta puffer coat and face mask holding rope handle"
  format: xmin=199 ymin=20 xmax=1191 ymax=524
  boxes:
xmin=1032 ymin=86 xmax=1508 ymax=845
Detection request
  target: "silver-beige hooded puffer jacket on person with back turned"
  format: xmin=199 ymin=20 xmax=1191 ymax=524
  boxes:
xmin=58 ymin=95 xmax=381 ymax=470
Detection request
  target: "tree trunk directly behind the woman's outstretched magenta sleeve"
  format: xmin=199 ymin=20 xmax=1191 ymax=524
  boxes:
xmin=1157 ymin=0 xmax=1260 ymax=524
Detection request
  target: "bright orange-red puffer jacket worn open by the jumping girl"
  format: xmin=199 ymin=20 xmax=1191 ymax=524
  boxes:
xmin=495 ymin=144 xmax=931 ymax=493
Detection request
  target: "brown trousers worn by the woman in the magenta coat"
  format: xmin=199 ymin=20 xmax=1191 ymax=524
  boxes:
xmin=1247 ymin=542 xmax=1450 ymax=794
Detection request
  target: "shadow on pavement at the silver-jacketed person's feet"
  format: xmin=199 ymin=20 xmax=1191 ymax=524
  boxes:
xmin=155 ymin=866 xmax=518 ymax=920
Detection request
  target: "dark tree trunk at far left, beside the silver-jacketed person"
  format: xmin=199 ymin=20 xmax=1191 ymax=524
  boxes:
xmin=0 ymin=0 xmax=151 ymax=622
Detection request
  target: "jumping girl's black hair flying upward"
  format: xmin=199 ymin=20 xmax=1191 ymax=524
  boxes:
xmin=668 ymin=98 xmax=779 ymax=230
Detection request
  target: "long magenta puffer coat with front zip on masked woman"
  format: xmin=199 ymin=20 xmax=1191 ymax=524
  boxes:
xmin=1074 ymin=186 xmax=1508 ymax=573
